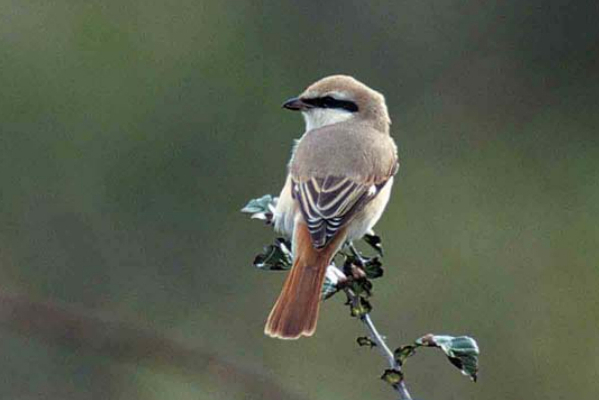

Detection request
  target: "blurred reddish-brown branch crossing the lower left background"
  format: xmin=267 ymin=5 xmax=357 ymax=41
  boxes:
xmin=0 ymin=290 xmax=314 ymax=400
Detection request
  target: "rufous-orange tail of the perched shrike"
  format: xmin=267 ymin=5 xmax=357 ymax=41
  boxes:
xmin=264 ymin=223 xmax=345 ymax=339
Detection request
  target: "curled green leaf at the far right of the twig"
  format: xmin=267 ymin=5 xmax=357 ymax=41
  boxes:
xmin=416 ymin=334 xmax=480 ymax=382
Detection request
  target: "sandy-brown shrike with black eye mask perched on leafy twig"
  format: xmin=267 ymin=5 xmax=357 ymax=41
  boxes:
xmin=264 ymin=75 xmax=399 ymax=339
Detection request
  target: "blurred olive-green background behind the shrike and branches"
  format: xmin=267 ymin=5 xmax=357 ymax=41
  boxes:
xmin=0 ymin=0 xmax=599 ymax=400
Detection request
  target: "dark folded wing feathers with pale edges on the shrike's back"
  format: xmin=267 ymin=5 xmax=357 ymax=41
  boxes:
xmin=292 ymin=163 xmax=399 ymax=248
